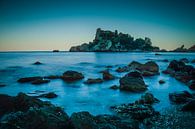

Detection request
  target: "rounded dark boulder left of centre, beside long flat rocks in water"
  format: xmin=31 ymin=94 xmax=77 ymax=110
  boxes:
xmin=62 ymin=70 xmax=84 ymax=82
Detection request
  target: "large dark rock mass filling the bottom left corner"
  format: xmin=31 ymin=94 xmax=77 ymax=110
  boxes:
xmin=0 ymin=93 xmax=71 ymax=129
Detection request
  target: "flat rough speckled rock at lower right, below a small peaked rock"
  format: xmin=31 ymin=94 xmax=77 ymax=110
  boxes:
xmin=111 ymin=103 xmax=159 ymax=121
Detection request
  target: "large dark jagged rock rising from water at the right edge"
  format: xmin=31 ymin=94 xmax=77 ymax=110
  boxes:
xmin=163 ymin=60 xmax=195 ymax=84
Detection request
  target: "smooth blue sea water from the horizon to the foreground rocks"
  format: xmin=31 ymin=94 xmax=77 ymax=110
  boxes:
xmin=0 ymin=52 xmax=195 ymax=115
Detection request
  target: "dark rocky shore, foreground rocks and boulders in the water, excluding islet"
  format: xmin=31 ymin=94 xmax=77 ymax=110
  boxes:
xmin=0 ymin=58 xmax=195 ymax=129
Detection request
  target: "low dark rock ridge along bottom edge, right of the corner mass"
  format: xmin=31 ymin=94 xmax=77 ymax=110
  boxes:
xmin=71 ymin=112 xmax=139 ymax=129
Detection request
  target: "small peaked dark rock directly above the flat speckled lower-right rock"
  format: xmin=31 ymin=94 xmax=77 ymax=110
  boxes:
xmin=135 ymin=93 xmax=160 ymax=104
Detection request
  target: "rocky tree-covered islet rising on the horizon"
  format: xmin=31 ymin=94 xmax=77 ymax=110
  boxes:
xmin=70 ymin=28 xmax=159 ymax=52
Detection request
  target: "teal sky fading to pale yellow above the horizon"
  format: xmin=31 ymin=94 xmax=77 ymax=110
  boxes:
xmin=0 ymin=0 xmax=195 ymax=51
